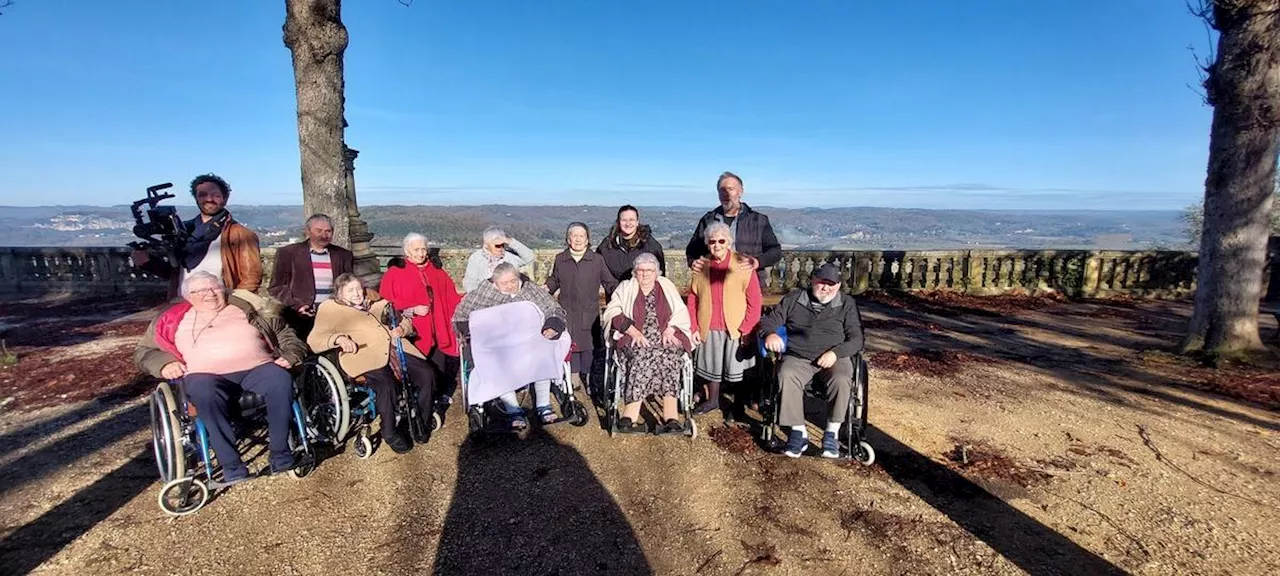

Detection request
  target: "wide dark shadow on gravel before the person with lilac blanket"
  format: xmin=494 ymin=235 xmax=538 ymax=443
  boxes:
xmin=432 ymin=429 xmax=653 ymax=575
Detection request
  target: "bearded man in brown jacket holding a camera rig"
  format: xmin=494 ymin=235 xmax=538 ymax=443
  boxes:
xmin=133 ymin=174 xmax=262 ymax=296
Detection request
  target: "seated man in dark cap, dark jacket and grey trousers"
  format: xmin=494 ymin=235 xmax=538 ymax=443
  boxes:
xmin=759 ymin=264 xmax=863 ymax=458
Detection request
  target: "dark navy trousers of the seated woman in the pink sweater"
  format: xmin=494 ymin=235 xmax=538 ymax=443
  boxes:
xmin=183 ymin=362 xmax=293 ymax=480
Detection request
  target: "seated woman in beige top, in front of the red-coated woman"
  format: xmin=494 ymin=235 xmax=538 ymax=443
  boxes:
xmin=307 ymin=274 xmax=443 ymax=454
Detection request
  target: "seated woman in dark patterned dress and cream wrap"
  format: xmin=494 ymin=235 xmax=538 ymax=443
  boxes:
xmin=603 ymin=253 xmax=692 ymax=434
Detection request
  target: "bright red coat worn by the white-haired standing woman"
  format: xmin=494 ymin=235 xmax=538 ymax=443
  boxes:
xmin=378 ymin=259 xmax=462 ymax=356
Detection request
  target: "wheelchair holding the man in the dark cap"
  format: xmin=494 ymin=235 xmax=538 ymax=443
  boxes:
xmin=758 ymin=326 xmax=876 ymax=466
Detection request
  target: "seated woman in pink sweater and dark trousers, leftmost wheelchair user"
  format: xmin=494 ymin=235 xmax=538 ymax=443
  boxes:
xmin=133 ymin=270 xmax=307 ymax=485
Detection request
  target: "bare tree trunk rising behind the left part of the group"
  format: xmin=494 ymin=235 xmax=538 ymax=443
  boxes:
xmin=284 ymin=0 xmax=351 ymax=247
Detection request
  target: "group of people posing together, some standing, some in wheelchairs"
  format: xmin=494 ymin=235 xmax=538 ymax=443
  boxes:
xmin=133 ymin=173 xmax=863 ymax=483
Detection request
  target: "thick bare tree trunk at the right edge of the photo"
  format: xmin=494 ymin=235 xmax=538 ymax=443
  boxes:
xmin=1181 ymin=0 xmax=1280 ymax=357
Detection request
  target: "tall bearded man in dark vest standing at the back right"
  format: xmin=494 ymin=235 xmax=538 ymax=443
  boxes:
xmin=685 ymin=172 xmax=782 ymax=289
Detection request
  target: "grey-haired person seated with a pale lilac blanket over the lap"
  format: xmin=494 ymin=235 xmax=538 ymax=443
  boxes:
xmin=453 ymin=262 xmax=586 ymax=433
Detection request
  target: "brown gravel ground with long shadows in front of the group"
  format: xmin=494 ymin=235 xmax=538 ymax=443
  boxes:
xmin=0 ymin=296 xmax=1280 ymax=575
